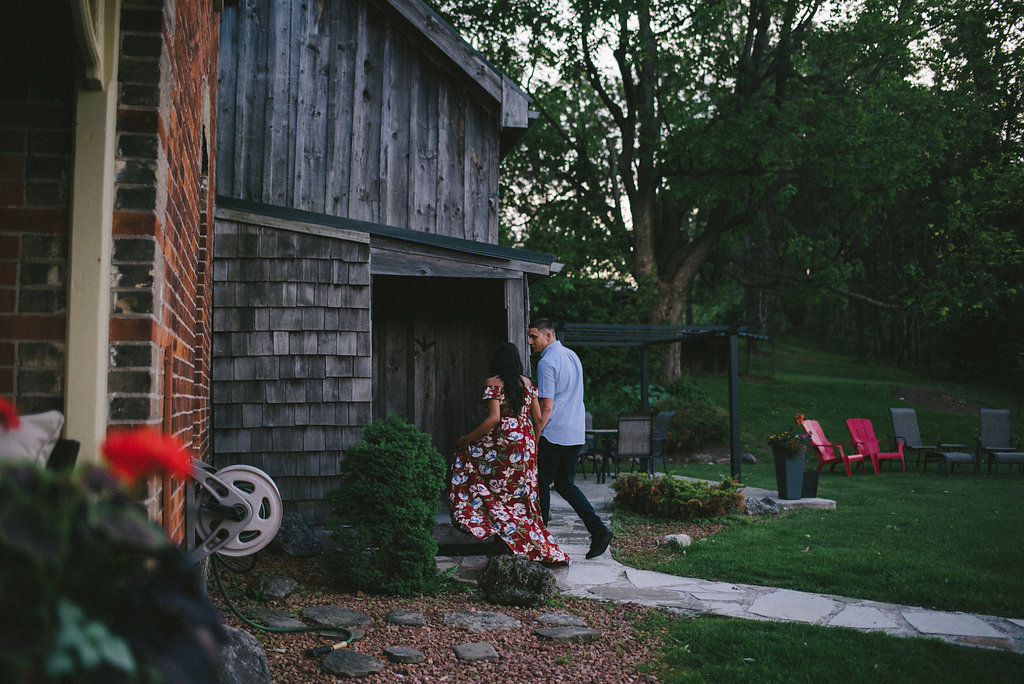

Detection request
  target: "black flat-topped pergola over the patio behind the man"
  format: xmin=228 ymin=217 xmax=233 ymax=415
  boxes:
xmin=555 ymin=323 xmax=767 ymax=478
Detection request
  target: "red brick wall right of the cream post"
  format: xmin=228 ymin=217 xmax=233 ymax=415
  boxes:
xmin=111 ymin=0 xmax=219 ymax=540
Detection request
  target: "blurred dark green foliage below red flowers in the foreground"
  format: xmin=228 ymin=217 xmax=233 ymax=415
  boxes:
xmin=0 ymin=464 xmax=220 ymax=683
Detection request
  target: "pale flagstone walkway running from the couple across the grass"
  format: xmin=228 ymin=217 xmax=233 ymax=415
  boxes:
xmin=437 ymin=477 xmax=1024 ymax=653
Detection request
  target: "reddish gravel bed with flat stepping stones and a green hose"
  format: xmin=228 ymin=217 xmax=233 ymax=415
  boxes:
xmin=210 ymin=552 xmax=668 ymax=684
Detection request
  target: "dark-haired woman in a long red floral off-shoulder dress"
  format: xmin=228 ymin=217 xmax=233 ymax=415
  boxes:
xmin=449 ymin=342 xmax=569 ymax=563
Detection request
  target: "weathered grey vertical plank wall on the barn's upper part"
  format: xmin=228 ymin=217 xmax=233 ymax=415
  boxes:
xmin=217 ymin=0 xmax=501 ymax=244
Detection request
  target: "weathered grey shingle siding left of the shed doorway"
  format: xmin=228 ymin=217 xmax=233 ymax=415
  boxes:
xmin=213 ymin=212 xmax=372 ymax=523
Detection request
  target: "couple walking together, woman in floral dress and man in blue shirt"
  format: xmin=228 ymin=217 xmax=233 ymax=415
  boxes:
xmin=449 ymin=318 xmax=611 ymax=564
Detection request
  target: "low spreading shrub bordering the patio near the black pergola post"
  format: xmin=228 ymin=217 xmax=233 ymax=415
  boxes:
xmin=612 ymin=474 xmax=745 ymax=521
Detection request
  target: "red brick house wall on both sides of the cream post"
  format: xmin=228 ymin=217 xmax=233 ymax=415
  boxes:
xmin=0 ymin=0 xmax=219 ymax=541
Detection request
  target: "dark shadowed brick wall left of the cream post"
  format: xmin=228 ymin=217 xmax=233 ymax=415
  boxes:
xmin=0 ymin=0 xmax=75 ymax=413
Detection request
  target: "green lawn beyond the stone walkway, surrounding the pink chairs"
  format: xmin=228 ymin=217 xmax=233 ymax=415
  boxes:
xmin=618 ymin=345 xmax=1024 ymax=617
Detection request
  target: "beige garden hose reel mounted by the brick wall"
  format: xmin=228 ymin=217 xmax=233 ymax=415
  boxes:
xmin=190 ymin=459 xmax=284 ymax=561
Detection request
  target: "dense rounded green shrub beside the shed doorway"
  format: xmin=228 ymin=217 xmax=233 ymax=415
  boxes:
xmin=328 ymin=416 xmax=444 ymax=596
